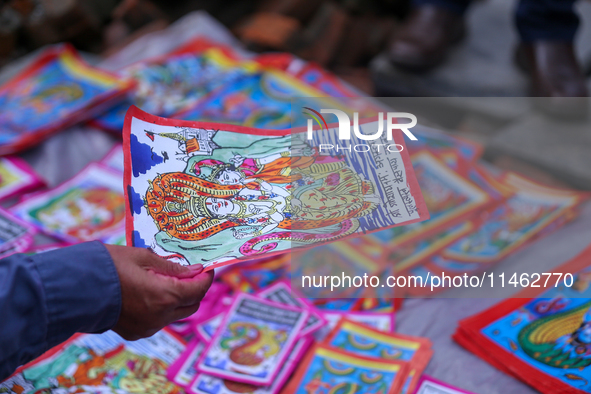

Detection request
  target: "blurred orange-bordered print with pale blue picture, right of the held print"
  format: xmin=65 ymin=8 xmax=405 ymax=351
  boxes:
xmin=443 ymin=173 xmax=589 ymax=263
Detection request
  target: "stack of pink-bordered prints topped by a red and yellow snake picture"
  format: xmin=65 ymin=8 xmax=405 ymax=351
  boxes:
xmin=168 ymin=290 xmax=314 ymax=393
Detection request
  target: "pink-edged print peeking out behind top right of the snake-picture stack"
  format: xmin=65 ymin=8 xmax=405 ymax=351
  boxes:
xmin=257 ymin=281 xmax=326 ymax=337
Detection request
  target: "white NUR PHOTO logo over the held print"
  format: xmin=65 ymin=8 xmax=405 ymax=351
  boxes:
xmin=303 ymin=107 xmax=417 ymax=152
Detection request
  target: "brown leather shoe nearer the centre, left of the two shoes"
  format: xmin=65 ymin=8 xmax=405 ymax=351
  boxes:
xmin=388 ymin=5 xmax=466 ymax=72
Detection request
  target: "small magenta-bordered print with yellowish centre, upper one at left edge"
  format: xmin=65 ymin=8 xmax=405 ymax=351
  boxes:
xmin=0 ymin=157 xmax=45 ymax=200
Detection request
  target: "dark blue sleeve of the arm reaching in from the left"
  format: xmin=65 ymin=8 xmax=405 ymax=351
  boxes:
xmin=0 ymin=242 xmax=121 ymax=381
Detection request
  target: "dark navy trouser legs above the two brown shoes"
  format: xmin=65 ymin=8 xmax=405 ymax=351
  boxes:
xmin=413 ymin=0 xmax=579 ymax=42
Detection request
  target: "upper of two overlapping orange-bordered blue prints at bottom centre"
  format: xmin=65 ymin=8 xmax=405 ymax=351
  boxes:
xmin=325 ymin=319 xmax=433 ymax=393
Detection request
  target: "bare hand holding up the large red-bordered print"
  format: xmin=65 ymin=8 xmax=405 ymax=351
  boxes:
xmin=105 ymin=245 xmax=213 ymax=341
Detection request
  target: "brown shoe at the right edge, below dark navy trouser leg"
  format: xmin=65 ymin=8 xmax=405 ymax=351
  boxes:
xmin=515 ymin=41 xmax=589 ymax=117
